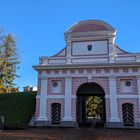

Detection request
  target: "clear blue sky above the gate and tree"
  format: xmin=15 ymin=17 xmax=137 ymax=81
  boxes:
xmin=0 ymin=0 xmax=140 ymax=90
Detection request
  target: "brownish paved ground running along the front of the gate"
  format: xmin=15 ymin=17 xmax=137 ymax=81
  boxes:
xmin=0 ymin=128 xmax=140 ymax=140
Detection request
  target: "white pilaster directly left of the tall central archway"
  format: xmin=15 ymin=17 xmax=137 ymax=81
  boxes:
xmin=63 ymin=77 xmax=72 ymax=121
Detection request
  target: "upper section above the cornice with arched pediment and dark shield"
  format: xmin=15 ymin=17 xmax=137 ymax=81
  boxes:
xmin=35 ymin=20 xmax=140 ymax=66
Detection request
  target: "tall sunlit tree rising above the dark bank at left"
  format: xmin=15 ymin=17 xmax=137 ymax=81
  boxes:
xmin=0 ymin=33 xmax=19 ymax=93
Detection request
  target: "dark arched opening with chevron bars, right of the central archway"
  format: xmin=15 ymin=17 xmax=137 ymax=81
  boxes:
xmin=122 ymin=103 xmax=134 ymax=126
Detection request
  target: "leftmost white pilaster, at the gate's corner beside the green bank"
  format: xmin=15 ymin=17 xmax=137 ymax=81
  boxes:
xmin=38 ymin=78 xmax=48 ymax=121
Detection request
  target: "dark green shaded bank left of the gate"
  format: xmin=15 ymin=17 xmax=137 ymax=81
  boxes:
xmin=0 ymin=92 xmax=37 ymax=127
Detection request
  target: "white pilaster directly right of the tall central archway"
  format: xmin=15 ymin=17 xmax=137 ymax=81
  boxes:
xmin=109 ymin=76 xmax=120 ymax=122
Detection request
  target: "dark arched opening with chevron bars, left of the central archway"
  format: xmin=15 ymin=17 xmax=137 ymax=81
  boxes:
xmin=51 ymin=103 xmax=61 ymax=124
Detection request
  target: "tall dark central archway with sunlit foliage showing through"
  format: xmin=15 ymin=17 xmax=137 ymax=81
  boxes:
xmin=77 ymin=83 xmax=106 ymax=127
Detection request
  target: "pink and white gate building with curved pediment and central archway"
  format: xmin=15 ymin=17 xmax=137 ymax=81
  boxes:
xmin=33 ymin=20 xmax=140 ymax=128
